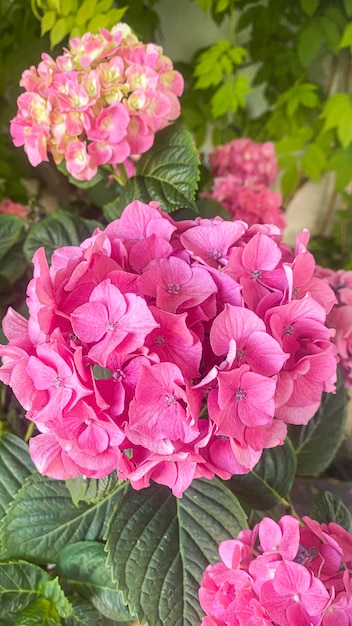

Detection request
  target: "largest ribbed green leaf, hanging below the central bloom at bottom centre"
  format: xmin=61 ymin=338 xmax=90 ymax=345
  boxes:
xmin=107 ymin=479 xmax=246 ymax=626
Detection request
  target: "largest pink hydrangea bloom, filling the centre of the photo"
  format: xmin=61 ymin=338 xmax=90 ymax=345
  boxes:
xmin=0 ymin=201 xmax=337 ymax=496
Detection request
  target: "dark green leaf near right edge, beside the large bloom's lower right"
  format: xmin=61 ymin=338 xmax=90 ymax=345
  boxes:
xmin=289 ymin=368 xmax=347 ymax=476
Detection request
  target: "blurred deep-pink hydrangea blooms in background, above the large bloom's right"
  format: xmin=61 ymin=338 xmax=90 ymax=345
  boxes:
xmin=209 ymin=139 xmax=286 ymax=229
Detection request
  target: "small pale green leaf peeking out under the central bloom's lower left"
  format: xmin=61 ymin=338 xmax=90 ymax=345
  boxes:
xmin=66 ymin=472 xmax=121 ymax=506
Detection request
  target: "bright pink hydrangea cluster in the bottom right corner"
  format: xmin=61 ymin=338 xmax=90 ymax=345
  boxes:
xmin=199 ymin=515 xmax=352 ymax=626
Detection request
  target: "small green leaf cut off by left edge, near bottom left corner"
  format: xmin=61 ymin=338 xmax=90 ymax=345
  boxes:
xmin=0 ymin=561 xmax=49 ymax=618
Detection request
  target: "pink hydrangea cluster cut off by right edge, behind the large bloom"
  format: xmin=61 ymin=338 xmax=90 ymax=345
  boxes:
xmin=315 ymin=267 xmax=352 ymax=388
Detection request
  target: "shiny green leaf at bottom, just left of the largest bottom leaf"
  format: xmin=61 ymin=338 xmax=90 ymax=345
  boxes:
xmin=57 ymin=541 xmax=133 ymax=622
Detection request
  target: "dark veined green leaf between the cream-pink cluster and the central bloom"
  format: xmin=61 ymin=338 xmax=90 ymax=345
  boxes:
xmin=104 ymin=125 xmax=199 ymax=221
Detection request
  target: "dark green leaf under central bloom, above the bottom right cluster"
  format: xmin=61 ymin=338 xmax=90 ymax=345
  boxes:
xmin=229 ymin=438 xmax=296 ymax=511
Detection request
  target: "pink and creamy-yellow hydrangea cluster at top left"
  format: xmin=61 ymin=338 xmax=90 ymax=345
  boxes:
xmin=10 ymin=23 xmax=183 ymax=180
